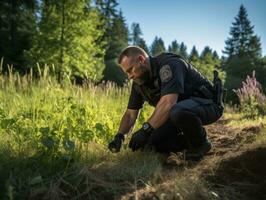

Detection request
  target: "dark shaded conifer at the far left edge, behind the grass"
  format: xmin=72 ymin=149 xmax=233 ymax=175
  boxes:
xmin=0 ymin=0 xmax=37 ymax=71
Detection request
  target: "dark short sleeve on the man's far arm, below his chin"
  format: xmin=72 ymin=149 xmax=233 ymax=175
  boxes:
xmin=127 ymin=83 xmax=144 ymax=110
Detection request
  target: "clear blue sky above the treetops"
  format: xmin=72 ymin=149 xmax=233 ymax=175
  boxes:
xmin=118 ymin=0 xmax=266 ymax=56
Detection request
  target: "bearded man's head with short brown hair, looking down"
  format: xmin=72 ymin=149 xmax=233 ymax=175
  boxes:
xmin=118 ymin=46 xmax=150 ymax=85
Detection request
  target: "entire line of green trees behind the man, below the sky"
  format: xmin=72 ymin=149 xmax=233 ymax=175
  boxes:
xmin=0 ymin=0 xmax=266 ymax=101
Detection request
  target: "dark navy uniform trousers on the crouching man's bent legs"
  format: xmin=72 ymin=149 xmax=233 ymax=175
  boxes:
xmin=147 ymin=97 xmax=223 ymax=153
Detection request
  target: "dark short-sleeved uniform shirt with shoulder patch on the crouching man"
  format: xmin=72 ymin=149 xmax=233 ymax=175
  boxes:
xmin=128 ymin=53 xmax=212 ymax=110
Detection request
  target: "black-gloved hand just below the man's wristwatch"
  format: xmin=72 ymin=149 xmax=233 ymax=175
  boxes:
xmin=128 ymin=128 xmax=150 ymax=151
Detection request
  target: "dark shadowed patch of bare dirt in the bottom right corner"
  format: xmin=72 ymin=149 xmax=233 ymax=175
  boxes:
xmin=207 ymin=146 xmax=266 ymax=199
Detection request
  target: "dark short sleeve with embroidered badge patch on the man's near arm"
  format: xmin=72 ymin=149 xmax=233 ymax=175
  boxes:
xmin=159 ymin=59 xmax=187 ymax=96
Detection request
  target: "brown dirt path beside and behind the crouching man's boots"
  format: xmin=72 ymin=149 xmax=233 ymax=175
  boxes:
xmin=119 ymin=119 xmax=266 ymax=200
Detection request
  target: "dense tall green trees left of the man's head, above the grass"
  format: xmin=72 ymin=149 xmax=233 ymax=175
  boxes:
xmin=0 ymin=0 xmax=129 ymax=82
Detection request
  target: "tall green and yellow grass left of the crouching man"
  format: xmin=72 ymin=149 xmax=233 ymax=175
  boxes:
xmin=0 ymin=61 xmax=156 ymax=199
